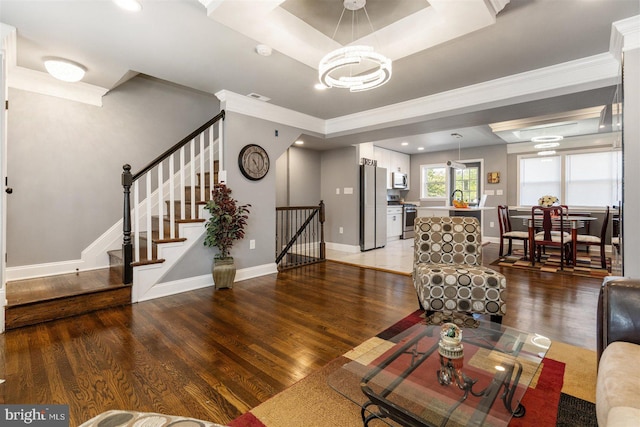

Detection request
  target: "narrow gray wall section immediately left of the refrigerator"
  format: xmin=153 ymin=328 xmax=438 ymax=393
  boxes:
xmin=321 ymin=147 xmax=360 ymax=246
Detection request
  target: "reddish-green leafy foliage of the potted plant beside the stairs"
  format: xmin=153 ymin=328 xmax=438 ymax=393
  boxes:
xmin=204 ymin=184 xmax=251 ymax=259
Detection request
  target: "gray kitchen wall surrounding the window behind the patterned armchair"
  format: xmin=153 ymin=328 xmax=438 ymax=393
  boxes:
xmin=406 ymin=145 xmax=508 ymax=237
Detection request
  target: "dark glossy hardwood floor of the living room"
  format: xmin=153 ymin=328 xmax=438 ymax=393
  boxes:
xmin=0 ymin=245 xmax=600 ymax=426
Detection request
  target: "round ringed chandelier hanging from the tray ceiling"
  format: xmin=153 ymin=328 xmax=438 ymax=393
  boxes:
xmin=318 ymin=0 xmax=391 ymax=92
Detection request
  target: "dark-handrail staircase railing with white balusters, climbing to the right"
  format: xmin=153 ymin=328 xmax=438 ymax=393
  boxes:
xmin=122 ymin=110 xmax=225 ymax=284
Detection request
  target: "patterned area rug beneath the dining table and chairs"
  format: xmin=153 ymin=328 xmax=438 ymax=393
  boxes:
xmin=491 ymin=249 xmax=611 ymax=279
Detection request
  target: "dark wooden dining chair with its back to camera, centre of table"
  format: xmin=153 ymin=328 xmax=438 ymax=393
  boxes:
xmin=530 ymin=206 xmax=572 ymax=270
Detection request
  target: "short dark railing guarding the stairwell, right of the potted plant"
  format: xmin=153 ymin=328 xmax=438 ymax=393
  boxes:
xmin=276 ymin=200 xmax=326 ymax=270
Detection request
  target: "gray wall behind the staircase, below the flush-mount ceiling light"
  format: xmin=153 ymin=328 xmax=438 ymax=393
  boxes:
xmin=7 ymin=77 xmax=220 ymax=267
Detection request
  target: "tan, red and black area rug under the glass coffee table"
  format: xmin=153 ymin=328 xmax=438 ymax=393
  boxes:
xmin=229 ymin=311 xmax=597 ymax=427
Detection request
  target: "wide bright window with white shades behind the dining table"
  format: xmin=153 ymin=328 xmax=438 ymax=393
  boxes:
xmin=519 ymin=150 xmax=622 ymax=207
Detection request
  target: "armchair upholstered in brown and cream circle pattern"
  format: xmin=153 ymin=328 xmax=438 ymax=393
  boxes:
xmin=413 ymin=216 xmax=506 ymax=323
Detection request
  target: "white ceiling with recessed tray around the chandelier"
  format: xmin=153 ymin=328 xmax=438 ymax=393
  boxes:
xmin=0 ymin=0 xmax=640 ymax=153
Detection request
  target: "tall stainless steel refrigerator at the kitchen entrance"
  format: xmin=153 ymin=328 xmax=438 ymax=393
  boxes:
xmin=360 ymin=165 xmax=387 ymax=251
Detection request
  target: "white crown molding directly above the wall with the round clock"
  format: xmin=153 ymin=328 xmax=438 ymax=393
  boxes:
xmin=215 ymin=90 xmax=326 ymax=135
